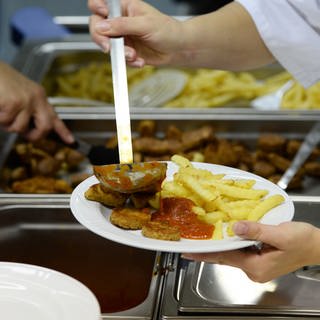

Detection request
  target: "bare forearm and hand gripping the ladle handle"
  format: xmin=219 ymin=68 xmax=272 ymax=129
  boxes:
xmin=88 ymin=0 xmax=274 ymax=70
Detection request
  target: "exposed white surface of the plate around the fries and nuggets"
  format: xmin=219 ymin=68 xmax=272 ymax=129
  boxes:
xmin=70 ymin=162 xmax=294 ymax=252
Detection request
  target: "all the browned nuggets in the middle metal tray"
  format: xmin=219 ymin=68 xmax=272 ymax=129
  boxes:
xmin=1 ymin=120 xmax=320 ymax=193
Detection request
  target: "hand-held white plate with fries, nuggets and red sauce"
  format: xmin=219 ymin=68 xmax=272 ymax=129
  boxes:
xmin=70 ymin=155 xmax=294 ymax=252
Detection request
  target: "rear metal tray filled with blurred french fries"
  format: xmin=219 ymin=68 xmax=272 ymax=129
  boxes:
xmin=15 ymin=38 xmax=320 ymax=113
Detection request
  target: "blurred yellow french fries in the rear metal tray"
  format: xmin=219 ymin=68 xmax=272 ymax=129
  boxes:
xmin=43 ymin=62 xmax=320 ymax=110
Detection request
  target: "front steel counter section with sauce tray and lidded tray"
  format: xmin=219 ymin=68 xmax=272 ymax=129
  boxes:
xmin=0 ymin=194 xmax=320 ymax=320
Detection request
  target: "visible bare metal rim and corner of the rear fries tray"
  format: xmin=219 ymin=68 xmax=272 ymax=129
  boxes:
xmin=14 ymin=35 xmax=320 ymax=120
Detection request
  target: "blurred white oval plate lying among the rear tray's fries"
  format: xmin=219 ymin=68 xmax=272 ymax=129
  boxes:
xmin=129 ymin=69 xmax=187 ymax=108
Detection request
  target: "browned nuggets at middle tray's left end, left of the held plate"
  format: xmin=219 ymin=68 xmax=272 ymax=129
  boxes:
xmin=1 ymin=138 xmax=90 ymax=194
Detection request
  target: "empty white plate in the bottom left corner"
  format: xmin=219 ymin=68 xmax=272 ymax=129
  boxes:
xmin=0 ymin=262 xmax=101 ymax=320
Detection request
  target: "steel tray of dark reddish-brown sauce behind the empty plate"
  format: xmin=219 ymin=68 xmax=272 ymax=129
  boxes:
xmin=0 ymin=195 xmax=163 ymax=320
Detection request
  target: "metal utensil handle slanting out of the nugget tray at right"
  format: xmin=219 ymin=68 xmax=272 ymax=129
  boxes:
xmin=277 ymin=122 xmax=320 ymax=190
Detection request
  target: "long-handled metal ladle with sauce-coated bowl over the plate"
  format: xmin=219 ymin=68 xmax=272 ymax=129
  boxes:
xmin=93 ymin=0 xmax=166 ymax=193
